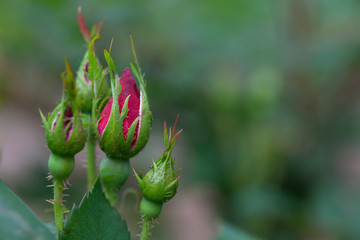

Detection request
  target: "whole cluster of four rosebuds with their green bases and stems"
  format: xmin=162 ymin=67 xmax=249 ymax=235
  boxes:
xmin=40 ymin=8 xmax=181 ymax=236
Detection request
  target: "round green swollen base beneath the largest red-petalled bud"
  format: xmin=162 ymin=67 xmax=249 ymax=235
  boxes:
xmin=99 ymin=157 xmax=130 ymax=190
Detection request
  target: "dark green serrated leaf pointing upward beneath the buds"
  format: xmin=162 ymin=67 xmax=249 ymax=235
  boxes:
xmin=60 ymin=180 xmax=130 ymax=240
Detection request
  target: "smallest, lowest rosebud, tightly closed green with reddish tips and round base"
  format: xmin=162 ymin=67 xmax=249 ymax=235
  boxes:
xmin=134 ymin=117 xmax=182 ymax=217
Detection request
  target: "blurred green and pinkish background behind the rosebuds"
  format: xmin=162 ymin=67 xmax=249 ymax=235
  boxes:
xmin=0 ymin=0 xmax=360 ymax=240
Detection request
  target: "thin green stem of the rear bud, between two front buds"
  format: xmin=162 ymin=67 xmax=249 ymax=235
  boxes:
xmin=87 ymin=133 xmax=96 ymax=191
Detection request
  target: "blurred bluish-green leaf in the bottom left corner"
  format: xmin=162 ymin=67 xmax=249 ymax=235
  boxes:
xmin=0 ymin=181 xmax=55 ymax=240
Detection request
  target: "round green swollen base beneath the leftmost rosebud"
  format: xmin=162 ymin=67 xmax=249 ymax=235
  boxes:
xmin=48 ymin=153 xmax=75 ymax=181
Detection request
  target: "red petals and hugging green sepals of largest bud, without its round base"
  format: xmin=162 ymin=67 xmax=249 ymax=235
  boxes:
xmin=97 ymin=68 xmax=152 ymax=159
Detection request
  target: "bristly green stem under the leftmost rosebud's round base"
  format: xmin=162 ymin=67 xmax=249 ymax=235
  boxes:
xmin=54 ymin=180 xmax=64 ymax=237
